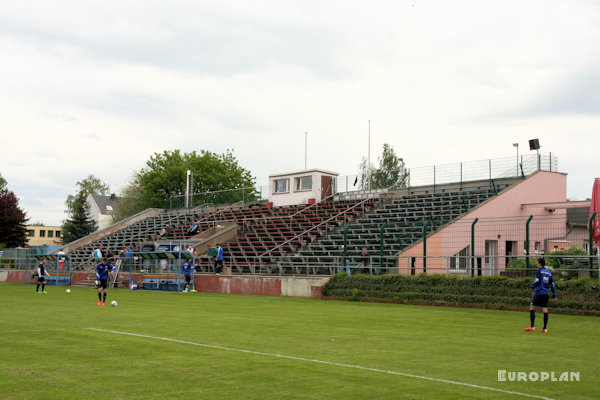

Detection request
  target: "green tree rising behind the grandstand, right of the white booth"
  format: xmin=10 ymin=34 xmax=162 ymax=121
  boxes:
xmin=358 ymin=143 xmax=408 ymax=190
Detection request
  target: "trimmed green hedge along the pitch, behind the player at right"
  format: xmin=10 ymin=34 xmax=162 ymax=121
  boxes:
xmin=321 ymin=273 xmax=600 ymax=315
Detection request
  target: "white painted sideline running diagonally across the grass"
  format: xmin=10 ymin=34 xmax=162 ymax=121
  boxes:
xmin=87 ymin=328 xmax=553 ymax=400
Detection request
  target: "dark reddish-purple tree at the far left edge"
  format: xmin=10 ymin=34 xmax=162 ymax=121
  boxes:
xmin=0 ymin=175 xmax=28 ymax=249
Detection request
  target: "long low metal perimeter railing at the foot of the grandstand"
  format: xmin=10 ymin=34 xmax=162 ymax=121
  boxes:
xmin=3 ymin=251 xmax=600 ymax=285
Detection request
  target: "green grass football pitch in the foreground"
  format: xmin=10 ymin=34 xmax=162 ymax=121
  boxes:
xmin=0 ymin=283 xmax=600 ymax=400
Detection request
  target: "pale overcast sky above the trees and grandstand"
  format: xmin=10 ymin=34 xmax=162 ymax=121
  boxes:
xmin=0 ymin=0 xmax=600 ymax=225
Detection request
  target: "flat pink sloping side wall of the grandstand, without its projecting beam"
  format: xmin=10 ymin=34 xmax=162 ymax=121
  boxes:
xmin=398 ymin=171 xmax=567 ymax=274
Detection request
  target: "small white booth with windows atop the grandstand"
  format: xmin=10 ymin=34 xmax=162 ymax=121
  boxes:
xmin=269 ymin=169 xmax=338 ymax=207
